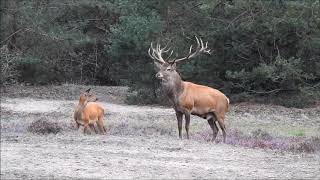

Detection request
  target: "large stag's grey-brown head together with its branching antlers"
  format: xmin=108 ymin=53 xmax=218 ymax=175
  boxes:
xmin=148 ymin=37 xmax=210 ymax=82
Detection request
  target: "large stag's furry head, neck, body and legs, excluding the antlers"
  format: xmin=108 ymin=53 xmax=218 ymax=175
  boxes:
xmin=156 ymin=69 xmax=229 ymax=142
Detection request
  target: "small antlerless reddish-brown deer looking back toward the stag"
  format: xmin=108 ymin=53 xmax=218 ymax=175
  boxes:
xmin=74 ymin=88 xmax=106 ymax=134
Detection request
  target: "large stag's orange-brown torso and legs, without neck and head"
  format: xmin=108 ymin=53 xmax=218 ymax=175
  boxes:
xmin=175 ymin=81 xmax=229 ymax=142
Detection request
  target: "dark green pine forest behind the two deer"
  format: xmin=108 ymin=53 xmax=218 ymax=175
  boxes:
xmin=0 ymin=0 xmax=320 ymax=108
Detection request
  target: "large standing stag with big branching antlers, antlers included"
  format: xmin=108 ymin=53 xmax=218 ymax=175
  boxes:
xmin=148 ymin=37 xmax=229 ymax=142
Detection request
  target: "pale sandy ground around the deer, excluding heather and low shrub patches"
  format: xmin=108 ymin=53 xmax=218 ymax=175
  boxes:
xmin=1 ymin=86 xmax=320 ymax=179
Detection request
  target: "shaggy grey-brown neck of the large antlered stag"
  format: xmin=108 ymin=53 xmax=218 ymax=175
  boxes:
xmin=161 ymin=73 xmax=184 ymax=106
